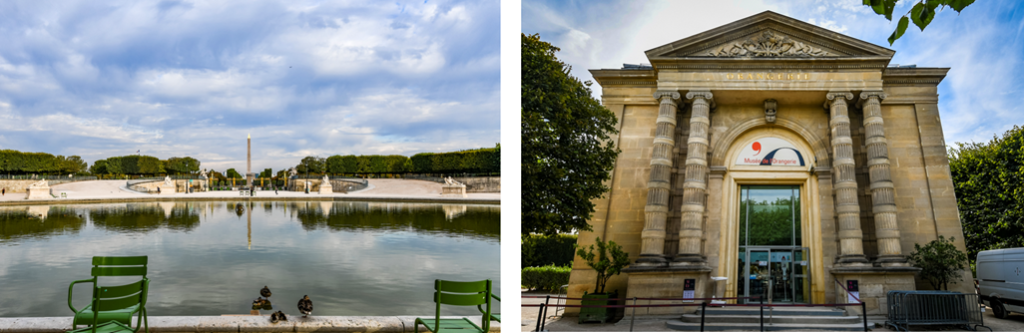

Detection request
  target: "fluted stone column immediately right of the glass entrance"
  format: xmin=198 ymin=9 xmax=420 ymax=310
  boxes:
xmin=825 ymin=91 xmax=867 ymax=265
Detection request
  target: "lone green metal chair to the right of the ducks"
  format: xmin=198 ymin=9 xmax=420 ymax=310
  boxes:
xmin=413 ymin=280 xmax=490 ymax=333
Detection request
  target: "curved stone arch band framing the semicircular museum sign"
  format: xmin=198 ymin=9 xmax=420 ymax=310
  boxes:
xmin=710 ymin=117 xmax=830 ymax=170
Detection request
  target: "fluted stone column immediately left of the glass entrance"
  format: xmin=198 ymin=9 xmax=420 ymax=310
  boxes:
xmin=675 ymin=91 xmax=714 ymax=262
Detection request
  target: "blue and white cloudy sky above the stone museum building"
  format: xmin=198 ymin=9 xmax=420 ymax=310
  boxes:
xmin=522 ymin=0 xmax=1024 ymax=144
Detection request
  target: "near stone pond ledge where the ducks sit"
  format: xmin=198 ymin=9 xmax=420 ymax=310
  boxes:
xmin=0 ymin=315 xmax=501 ymax=333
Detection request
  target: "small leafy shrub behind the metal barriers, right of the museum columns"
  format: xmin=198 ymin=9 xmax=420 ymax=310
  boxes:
xmin=907 ymin=235 xmax=967 ymax=290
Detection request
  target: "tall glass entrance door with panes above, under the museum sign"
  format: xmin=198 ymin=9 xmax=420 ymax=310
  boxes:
xmin=736 ymin=185 xmax=810 ymax=303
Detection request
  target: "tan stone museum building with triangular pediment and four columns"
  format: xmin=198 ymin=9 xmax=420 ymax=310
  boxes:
xmin=567 ymin=11 xmax=974 ymax=315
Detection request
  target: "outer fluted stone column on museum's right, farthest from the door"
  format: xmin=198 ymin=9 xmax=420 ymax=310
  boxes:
xmin=860 ymin=91 xmax=906 ymax=265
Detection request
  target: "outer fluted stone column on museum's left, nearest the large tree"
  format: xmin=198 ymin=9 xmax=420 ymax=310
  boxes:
xmin=637 ymin=91 xmax=680 ymax=264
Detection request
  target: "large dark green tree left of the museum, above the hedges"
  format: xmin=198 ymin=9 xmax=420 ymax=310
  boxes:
xmin=521 ymin=34 xmax=618 ymax=235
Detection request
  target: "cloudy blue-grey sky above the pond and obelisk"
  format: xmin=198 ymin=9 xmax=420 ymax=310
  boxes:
xmin=0 ymin=0 xmax=500 ymax=171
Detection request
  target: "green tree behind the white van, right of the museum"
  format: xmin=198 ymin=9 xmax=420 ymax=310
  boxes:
xmin=948 ymin=126 xmax=1024 ymax=260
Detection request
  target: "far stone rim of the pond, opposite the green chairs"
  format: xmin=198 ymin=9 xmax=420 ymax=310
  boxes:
xmin=0 ymin=197 xmax=502 ymax=204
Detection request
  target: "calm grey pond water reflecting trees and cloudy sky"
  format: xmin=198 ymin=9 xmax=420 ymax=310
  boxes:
xmin=0 ymin=202 xmax=501 ymax=317
